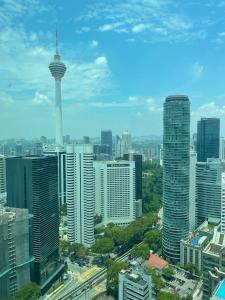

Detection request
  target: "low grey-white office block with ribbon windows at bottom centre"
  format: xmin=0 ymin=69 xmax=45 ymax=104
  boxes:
xmin=119 ymin=270 xmax=152 ymax=300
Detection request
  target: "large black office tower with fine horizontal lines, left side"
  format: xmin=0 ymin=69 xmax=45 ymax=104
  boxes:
xmin=6 ymin=156 xmax=64 ymax=292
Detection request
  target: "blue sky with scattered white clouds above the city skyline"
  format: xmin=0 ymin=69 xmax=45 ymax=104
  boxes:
xmin=0 ymin=0 xmax=225 ymax=139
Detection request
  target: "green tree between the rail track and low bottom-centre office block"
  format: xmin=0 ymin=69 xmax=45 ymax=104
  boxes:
xmin=106 ymin=259 xmax=128 ymax=299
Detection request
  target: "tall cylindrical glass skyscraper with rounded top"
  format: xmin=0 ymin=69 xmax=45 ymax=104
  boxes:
xmin=162 ymin=96 xmax=190 ymax=262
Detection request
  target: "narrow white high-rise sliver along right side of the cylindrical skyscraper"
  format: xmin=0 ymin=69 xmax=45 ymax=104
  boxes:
xmin=189 ymin=150 xmax=197 ymax=231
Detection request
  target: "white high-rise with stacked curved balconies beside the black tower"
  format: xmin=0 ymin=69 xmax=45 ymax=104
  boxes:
xmin=66 ymin=144 xmax=95 ymax=247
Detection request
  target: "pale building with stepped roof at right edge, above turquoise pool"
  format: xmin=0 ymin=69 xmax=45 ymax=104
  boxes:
xmin=202 ymin=227 xmax=225 ymax=300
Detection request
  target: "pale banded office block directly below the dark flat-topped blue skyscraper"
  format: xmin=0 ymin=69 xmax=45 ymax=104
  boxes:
xmin=196 ymin=159 xmax=223 ymax=226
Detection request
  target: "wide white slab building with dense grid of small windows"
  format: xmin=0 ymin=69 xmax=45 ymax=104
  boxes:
xmin=94 ymin=161 xmax=136 ymax=225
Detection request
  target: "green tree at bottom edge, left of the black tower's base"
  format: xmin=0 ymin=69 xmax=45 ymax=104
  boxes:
xmin=12 ymin=282 xmax=41 ymax=300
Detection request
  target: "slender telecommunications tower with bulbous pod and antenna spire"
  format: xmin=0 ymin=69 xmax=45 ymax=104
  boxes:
xmin=49 ymin=31 xmax=66 ymax=146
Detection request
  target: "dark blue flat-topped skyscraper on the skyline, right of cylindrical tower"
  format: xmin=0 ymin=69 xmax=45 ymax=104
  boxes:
xmin=197 ymin=118 xmax=220 ymax=162
